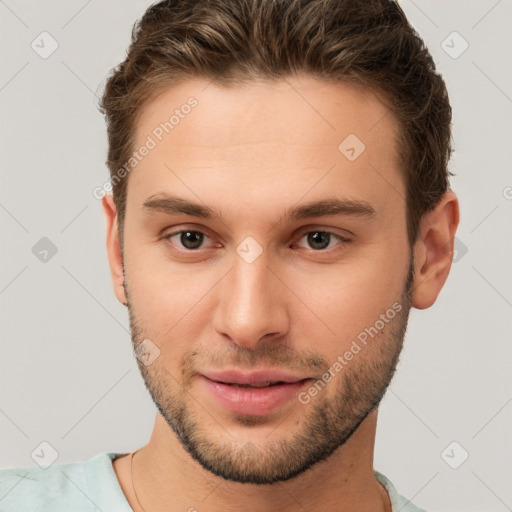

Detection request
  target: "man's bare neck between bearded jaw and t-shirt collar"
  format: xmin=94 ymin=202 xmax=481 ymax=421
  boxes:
xmin=116 ymin=411 xmax=391 ymax=512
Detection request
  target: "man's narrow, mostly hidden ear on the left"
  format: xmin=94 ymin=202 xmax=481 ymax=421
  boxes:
xmin=101 ymin=194 xmax=128 ymax=305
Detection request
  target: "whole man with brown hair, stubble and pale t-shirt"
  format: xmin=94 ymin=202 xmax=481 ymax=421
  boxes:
xmin=0 ymin=0 xmax=459 ymax=512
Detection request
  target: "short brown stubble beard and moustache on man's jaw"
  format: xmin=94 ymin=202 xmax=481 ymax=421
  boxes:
xmin=125 ymin=258 xmax=414 ymax=485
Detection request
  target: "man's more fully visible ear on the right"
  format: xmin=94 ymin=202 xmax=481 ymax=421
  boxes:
xmin=411 ymin=190 xmax=459 ymax=309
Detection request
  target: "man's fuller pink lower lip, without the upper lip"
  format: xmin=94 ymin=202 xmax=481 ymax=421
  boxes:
xmin=202 ymin=377 xmax=310 ymax=416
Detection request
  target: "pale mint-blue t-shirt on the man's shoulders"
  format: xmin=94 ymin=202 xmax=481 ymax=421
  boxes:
xmin=0 ymin=453 xmax=425 ymax=512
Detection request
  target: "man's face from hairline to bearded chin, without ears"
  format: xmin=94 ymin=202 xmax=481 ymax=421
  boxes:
xmin=118 ymin=76 xmax=413 ymax=484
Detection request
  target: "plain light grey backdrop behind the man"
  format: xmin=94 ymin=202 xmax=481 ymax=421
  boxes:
xmin=0 ymin=0 xmax=512 ymax=512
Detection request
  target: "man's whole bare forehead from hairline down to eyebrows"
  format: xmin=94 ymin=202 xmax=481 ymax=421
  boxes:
xmin=128 ymin=75 xmax=404 ymax=217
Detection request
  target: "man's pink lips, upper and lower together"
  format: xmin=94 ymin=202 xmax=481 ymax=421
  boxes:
xmin=201 ymin=369 xmax=311 ymax=416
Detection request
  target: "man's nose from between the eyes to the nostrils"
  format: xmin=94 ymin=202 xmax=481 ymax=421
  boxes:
xmin=213 ymin=246 xmax=289 ymax=349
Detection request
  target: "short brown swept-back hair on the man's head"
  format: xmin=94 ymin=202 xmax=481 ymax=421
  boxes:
xmin=100 ymin=0 xmax=453 ymax=247
